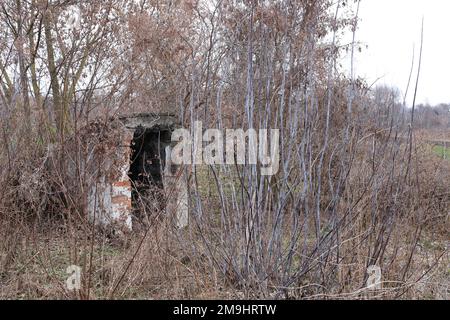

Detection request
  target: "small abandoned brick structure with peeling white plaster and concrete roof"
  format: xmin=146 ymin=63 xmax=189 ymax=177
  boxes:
xmin=82 ymin=114 xmax=188 ymax=231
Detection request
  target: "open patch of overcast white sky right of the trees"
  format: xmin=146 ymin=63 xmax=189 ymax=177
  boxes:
xmin=355 ymin=0 xmax=450 ymax=104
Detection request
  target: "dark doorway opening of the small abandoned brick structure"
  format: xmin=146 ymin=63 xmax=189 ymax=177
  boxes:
xmin=129 ymin=127 xmax=171 ymax=220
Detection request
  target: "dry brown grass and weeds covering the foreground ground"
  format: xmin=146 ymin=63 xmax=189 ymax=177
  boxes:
xmin=0 ymin=131 xmax=450 ymax=299
